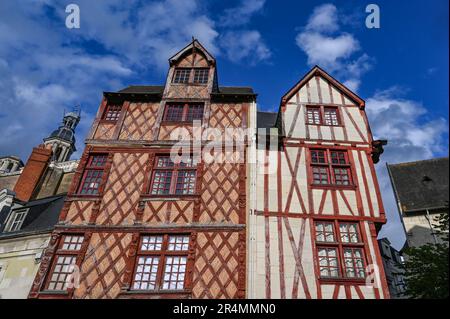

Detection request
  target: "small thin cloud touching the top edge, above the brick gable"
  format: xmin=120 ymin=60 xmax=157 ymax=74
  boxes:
xmin=220 ymin=0 xmax=266 ymax=26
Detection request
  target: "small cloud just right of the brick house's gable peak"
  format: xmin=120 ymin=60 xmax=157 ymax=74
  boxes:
xmin=221 ymin=30 xmax=271 ymax=64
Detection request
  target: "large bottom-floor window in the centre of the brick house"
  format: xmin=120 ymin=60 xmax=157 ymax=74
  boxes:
xmin=132 ymin=235 xmax=189 ymax=290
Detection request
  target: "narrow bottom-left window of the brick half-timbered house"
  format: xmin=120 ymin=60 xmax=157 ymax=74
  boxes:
xmin=46 ymin=235 xmax=84 ymax=291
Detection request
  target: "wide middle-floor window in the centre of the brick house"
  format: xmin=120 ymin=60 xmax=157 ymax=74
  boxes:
xmin=150 ymin=156 xmax=197 ymax=195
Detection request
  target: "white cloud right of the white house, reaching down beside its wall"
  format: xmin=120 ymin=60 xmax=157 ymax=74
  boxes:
xmin=366 ymin=87 xmax=448 ymax=249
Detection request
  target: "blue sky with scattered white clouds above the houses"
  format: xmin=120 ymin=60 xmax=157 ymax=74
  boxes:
xmin=0 ymin=0 xmax=449 ymax=247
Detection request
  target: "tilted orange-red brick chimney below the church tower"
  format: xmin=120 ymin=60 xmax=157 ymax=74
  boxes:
xmin=14 ymin=145 xmax=52 ymax=202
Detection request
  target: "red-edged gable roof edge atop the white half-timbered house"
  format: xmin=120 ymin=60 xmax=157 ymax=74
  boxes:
xmin=281 ymin=65 xmax=365 ymax=108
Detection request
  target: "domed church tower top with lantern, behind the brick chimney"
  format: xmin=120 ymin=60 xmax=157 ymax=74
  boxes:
xmin=44 ymin=109 xmax=81 ymax=162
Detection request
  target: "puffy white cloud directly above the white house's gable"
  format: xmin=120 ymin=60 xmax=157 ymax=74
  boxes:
xmin=295 ymin=4 xmax=374 ymax=91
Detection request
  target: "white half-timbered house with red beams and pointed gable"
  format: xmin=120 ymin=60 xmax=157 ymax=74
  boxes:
xmin=248 ymin=67 xmax=389 ymax=299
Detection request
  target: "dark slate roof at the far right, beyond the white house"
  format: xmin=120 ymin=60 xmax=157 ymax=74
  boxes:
xmin=387 ymin=157 xmax=449 ymax=213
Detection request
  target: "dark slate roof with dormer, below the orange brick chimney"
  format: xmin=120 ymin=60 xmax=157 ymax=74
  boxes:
xmin=0 ymin=194 xmax=65 ymax=239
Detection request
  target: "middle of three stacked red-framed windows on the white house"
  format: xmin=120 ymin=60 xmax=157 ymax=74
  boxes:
xmin=310 ymin=149 xmax=353 ymax=186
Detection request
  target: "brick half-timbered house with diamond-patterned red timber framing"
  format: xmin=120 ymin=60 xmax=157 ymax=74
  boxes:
xmin=29 ymin=40 xmax=256 ymax=299
